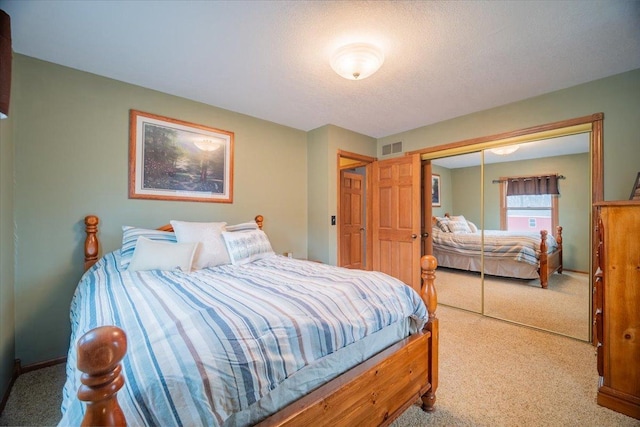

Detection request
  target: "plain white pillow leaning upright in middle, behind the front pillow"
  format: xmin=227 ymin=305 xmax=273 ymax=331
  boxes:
xmin=171 ymin=221 xmax=231 ymax=270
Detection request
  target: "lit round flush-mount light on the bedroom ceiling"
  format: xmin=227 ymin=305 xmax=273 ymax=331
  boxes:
xmin=331 ymin=43 xmax=384 ymax=80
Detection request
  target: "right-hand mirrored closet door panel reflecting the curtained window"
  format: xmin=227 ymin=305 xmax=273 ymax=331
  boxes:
xmin=483 ymin=133 xmax=591 ymax=341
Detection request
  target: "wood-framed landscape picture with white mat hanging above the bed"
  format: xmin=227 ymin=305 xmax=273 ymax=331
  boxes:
xmin=129 ymin=110 xmax=234 ymax=203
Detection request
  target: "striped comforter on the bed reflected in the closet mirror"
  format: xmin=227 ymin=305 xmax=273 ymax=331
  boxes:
xmin=432 ymin=227 xmax=558 ymax=265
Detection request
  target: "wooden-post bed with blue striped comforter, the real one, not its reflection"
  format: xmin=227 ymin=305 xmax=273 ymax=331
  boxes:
xmin=60 ymin=216 xmax=438 ymax=426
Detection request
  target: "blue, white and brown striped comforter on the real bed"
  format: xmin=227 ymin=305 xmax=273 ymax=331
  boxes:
xmin=60 ymin=251 xmax=427 ymax=426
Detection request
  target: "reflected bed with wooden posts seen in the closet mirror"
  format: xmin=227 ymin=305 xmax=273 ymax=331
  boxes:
xmin=432 ymin=213 xmax=562 ymax=289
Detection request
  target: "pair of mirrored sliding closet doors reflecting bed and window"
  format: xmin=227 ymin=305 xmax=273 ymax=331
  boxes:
xmin=431 ymin=133 xmax=591 ymax=341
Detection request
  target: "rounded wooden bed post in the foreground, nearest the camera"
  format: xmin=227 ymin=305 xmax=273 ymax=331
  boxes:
xmin=77 ymin=326 xmax=127 ymax=426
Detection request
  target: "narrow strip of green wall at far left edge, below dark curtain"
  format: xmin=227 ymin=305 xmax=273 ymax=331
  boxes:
xmin=0 ymin=100 xmax=15 ymax=399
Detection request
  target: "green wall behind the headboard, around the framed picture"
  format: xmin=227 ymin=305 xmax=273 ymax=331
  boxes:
xmin=11 ymin=55 xmax=307 ymax=364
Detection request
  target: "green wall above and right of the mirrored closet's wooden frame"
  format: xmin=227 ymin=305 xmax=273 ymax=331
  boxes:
xmin=377 ymin=69 xmax=640 ymax=200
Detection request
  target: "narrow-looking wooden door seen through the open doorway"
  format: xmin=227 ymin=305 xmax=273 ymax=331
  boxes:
xmin=339 ymin=171 xmax=365 ymax=268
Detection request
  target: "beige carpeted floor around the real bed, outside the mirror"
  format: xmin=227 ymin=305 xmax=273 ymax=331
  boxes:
xmin=0 ymin=307 xmax=640 ymax=427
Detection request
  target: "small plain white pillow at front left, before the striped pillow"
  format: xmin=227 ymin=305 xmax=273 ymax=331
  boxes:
xmin=127 ymin=236 xmax=197 ymax=272
